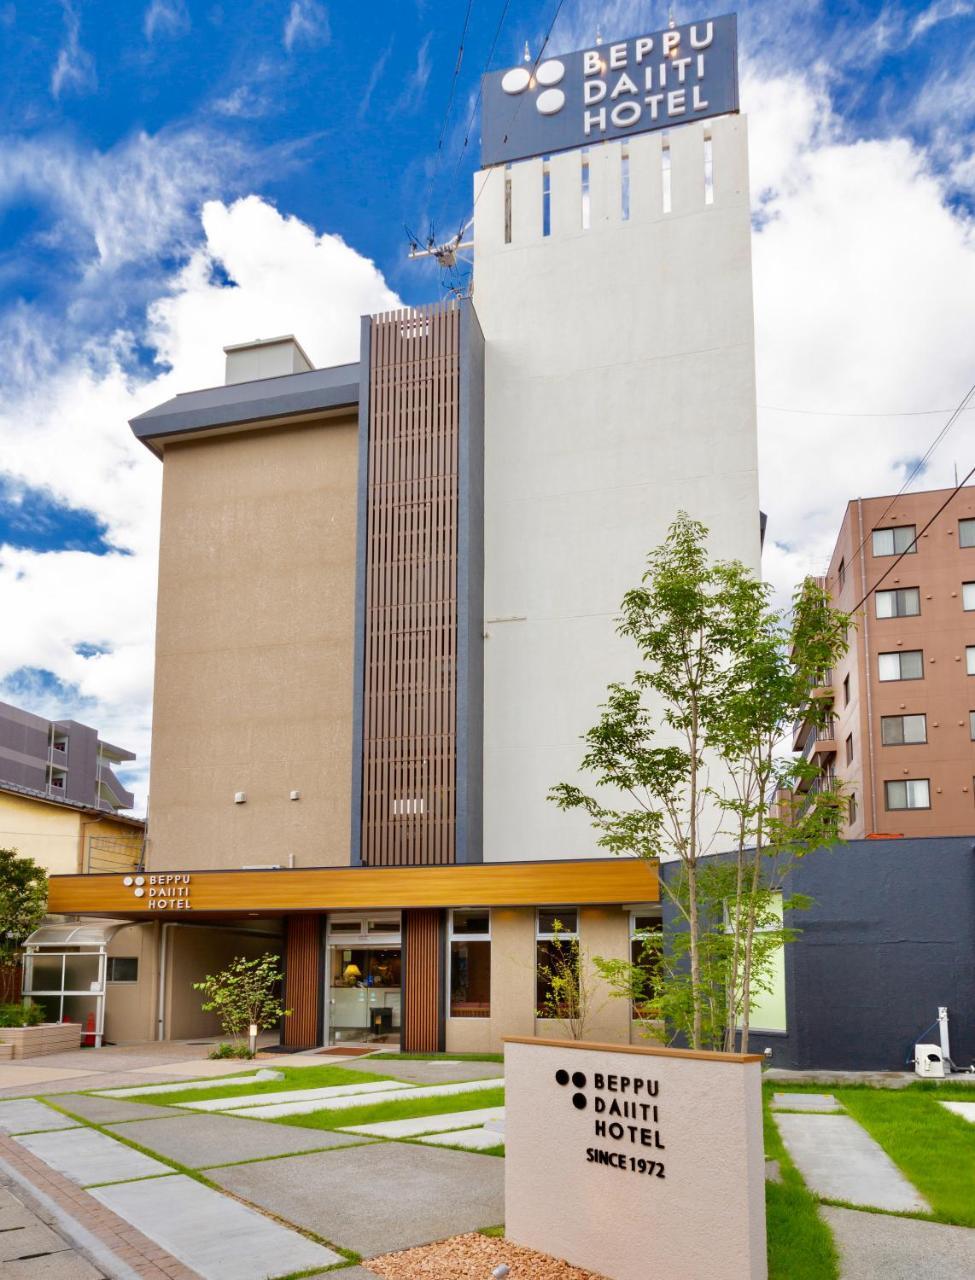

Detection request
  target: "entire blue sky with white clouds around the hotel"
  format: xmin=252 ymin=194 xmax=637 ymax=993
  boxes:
xmin=0 ymin=0 xmax=975 ymax=803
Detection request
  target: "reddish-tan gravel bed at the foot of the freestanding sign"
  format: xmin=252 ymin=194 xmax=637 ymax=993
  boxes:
xmin=366 ymin=1231 xmax=604 ymax=1280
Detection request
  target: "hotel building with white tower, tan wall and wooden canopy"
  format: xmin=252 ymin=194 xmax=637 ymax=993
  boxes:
xmin=43 ymin=37 xmax=760 ymax=1052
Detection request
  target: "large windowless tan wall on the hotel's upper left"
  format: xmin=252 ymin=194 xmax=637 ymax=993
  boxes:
xmin=148 ymin=417 xmax=357 ymax=870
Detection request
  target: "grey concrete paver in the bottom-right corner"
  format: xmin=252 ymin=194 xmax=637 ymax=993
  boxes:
xmin=820 ymin=1206 xmax=975 ymax=1280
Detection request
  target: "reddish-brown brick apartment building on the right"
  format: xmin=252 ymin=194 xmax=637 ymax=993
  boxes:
xmin=793 ymin=489 xmax=975 ymax=837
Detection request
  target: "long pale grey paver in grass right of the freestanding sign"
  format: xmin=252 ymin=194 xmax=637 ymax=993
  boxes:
xmin=775 ymin=1112 xmax=930 ymax=1213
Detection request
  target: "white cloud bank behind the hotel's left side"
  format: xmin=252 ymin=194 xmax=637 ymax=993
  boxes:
xmin=0 ymin=196 xmax=399 ymax=804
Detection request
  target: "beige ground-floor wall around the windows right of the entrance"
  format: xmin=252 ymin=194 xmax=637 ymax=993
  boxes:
xmin=447 ymin=906 xmax=630 ymax=1053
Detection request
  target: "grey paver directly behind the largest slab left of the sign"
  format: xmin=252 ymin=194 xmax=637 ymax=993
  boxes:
xmin=109 ymin=1112 xmax=371 ymax=1169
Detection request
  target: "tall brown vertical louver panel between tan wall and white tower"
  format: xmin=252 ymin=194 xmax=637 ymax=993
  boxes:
xmin=361 ymin=302 xmax=461 ymax=867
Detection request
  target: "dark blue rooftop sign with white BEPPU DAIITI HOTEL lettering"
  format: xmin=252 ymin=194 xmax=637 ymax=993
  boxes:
xmin=481 ymin=14 xmax=738 ymax=168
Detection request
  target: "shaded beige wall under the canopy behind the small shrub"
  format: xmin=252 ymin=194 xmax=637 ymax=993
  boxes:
xmin=165 ymin=922 xmax=281 ymax=1039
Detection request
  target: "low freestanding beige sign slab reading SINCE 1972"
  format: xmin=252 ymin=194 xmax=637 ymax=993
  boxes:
xmin=504 ymin=1038 xmax=768 ymax=1280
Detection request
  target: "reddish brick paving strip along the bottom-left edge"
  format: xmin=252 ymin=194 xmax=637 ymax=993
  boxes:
xmin=0 ymin=1134 xmax=200 ymax=1280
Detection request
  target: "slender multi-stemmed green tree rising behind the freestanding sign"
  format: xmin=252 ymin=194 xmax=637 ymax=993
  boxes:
xmin=550 ymin=512 xmax=848 ymax=1048
